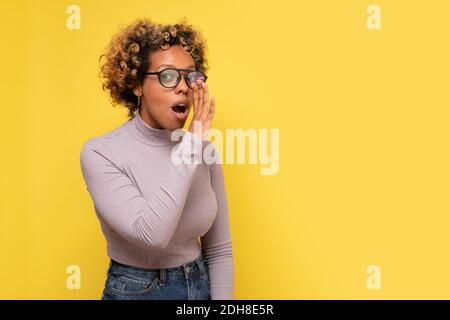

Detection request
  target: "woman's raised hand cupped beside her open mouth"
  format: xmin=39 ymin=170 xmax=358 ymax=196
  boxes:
xmin=189 ymin=80 xmax=216 ymax=139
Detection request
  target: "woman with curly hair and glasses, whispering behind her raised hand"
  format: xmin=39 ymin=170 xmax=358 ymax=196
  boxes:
xmin=80 ymin=19 xmax=233 ymax=300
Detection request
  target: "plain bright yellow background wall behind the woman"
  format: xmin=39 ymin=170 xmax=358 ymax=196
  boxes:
xmin=0 ymin=0 xmax=450 ymax=299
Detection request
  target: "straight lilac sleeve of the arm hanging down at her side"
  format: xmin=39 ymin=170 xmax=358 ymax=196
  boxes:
xmin=201 ymin=159 xmax=234 ymax=300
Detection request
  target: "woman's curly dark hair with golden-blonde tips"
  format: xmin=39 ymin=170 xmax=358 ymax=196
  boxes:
xmin=99 ymin=17 xmax=208 ymax=118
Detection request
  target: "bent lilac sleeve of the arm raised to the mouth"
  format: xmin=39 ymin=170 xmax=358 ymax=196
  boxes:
xmin=80 ymin=131 xmax=202 ymax=249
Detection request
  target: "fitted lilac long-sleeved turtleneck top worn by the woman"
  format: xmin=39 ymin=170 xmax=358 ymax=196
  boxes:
xmin=80 ymin=113 xmax=234 ymax=300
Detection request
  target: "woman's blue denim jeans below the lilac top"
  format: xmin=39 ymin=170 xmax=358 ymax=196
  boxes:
xmin=102 ymin=253 xmax=211 ymax=300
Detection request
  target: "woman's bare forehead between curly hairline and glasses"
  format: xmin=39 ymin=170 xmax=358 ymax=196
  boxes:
xmin=150 ymin=45 xmax=195 ymax=70
